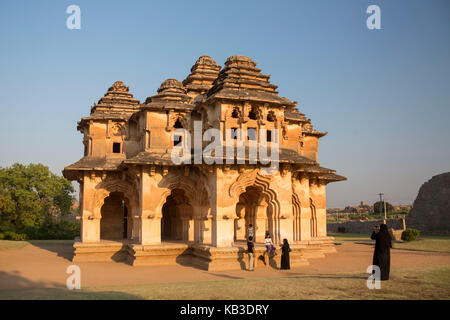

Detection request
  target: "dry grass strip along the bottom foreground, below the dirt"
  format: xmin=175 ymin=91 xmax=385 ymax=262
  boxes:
xmin=0 ymin=266 xmax=450 ymax=300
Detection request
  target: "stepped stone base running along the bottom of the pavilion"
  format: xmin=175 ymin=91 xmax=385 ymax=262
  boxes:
xmin=72 ymin=237 xmax=336 ymax=271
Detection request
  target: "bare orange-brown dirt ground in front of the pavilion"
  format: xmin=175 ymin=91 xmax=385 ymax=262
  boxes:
xmin=0 ymin=241 xmax=450 ymax=292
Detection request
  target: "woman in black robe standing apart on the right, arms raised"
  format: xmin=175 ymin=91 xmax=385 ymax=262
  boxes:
xmin=370 ymin=224 xmax=392 ymax=280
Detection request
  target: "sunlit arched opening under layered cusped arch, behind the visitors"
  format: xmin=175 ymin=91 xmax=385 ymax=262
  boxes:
xmin=235 ymin=186 xmax=276 ymax=242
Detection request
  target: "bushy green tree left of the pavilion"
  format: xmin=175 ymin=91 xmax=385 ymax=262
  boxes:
xmin=0 ymin=163 xmax=74 ymax=233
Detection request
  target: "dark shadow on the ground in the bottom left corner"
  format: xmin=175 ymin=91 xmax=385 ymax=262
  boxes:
xmin=0 ymin=271 xmax=142 ymax=300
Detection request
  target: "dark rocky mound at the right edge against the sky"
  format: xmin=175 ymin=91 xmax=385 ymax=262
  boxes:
xmin=406 ymin=172 xmax=450 ymax=233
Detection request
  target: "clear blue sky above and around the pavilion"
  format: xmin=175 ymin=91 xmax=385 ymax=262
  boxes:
xmin=0 ymin=0 xmax=450 ymax=207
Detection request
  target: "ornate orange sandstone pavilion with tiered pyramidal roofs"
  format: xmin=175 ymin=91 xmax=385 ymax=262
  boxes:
xmin=63 ymin=56 xmax=345 ymax=269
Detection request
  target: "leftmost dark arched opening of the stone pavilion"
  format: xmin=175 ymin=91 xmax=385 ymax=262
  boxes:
xmin=100 ymin=192 xmax=128 ymax=240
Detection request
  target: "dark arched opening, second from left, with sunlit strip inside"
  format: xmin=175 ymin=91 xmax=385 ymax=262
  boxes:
xmin=161 ymin=189 xmax=194 ymax=241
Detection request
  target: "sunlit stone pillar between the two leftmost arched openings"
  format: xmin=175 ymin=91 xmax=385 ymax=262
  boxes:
xmin=139 ymin=167 xmax=162 ymax=245
